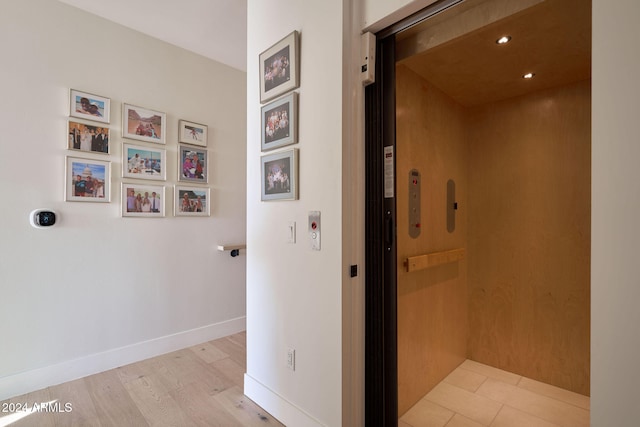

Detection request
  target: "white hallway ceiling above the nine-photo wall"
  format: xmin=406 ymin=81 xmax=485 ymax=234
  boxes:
xmin=59 ymin=0 xmax=247 ymax=71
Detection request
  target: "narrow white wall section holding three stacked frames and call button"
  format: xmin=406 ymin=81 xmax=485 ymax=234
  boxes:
xmin=245 ymin=0 xmax=344 ymax=426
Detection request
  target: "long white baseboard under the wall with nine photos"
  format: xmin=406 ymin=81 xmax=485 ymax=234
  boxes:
xmin=0 ymin=316 xmax=247 ymax=400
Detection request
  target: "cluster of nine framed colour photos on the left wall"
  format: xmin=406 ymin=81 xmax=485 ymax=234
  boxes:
xmin=64 ymin=89 xmax=211 ymax=218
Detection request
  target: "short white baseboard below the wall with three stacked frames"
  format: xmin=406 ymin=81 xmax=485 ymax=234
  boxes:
xmin=244 ymin=374 xmax=323 ymax=427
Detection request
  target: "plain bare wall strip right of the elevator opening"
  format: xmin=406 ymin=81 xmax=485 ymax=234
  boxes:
xmin=591 ymin=0 xmax=640 ymax=427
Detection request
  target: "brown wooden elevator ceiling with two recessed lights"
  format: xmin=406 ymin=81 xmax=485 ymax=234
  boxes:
xmin=398 ymin=0 xmax=591 ymax=106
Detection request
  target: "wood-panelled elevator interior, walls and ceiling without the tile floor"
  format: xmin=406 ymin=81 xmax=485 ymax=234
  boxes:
xmin=367 ymin=0 xmax=591 ymax=419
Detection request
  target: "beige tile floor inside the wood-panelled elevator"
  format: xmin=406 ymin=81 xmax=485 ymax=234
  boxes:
xmin=398 ymin=360 xmax=590 ymax=427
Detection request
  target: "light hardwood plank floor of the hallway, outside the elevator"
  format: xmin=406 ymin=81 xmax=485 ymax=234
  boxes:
xmin=0 ymin=332 xmax=283 ymax=427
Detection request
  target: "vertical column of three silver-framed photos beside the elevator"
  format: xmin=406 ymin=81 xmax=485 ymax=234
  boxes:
xmin=259 ymin=31 xmax=300 ymax=201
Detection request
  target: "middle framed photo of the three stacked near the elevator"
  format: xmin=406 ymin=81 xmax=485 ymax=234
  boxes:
xmin=261 ymin=92 xmax=298 ymax=151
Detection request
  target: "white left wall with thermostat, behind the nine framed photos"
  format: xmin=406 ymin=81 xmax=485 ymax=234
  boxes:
xmin=0 ymin=0 xmax=246 ymax=400
